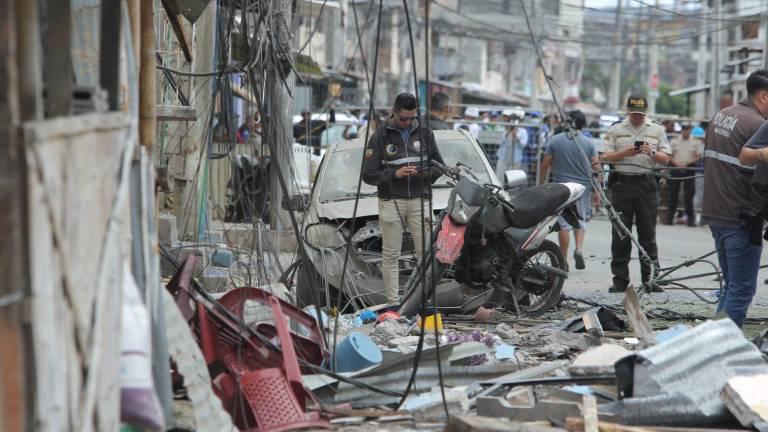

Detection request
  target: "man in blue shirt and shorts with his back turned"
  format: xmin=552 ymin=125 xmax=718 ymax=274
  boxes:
xmin=539 ymin=110 xmax=600 ymax=270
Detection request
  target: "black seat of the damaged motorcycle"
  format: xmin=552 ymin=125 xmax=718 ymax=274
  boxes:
xmin=505 ymin=183 xmax=571 ymax=228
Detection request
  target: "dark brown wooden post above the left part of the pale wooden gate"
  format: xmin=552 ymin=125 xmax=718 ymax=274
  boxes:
xmin=44 ymin=0 xmax=73 ymax=117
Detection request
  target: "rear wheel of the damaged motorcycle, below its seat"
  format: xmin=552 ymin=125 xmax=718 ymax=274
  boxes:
xmin=515 ymin=240 xmax=566 ymax=315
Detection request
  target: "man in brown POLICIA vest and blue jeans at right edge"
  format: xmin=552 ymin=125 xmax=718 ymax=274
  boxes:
xmin=701 ymin=69 xmax=768 ymax=326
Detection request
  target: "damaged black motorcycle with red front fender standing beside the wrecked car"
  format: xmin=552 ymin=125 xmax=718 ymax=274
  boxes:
xmin=398 ymin=161 xmax=584 ymax=316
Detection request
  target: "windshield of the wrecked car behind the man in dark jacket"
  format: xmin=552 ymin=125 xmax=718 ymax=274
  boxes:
xmin=318 ymin=139 xmax=491 ymax=202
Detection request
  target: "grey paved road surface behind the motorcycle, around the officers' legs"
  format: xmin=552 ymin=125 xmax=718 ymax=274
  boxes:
xmin=553 ymin=218 xmax=768 ymax=321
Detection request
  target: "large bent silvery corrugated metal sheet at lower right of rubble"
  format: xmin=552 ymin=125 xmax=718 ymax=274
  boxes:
xmin=622 ymin=319 xmax=768 ymax=425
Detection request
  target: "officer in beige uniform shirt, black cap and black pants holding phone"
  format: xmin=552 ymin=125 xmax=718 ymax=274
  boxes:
xmin=603 ymin=95 xmax=670 ymax=292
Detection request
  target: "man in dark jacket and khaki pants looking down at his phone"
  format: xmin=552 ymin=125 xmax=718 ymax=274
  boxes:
xmin=363 ymin=93 xmax=443 ymax=304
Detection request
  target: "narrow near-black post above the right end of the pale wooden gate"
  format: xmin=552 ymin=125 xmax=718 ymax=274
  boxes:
xmin=100 ymin=0 xmax=122 ymax=111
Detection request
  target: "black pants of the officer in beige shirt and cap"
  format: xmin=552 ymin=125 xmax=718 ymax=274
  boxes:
xmin=611 ymin=176 xmax=659 ymax=288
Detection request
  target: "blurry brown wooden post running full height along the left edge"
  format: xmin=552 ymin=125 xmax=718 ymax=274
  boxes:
xmin=0 ymin=0 xmax=28 ymax=431
